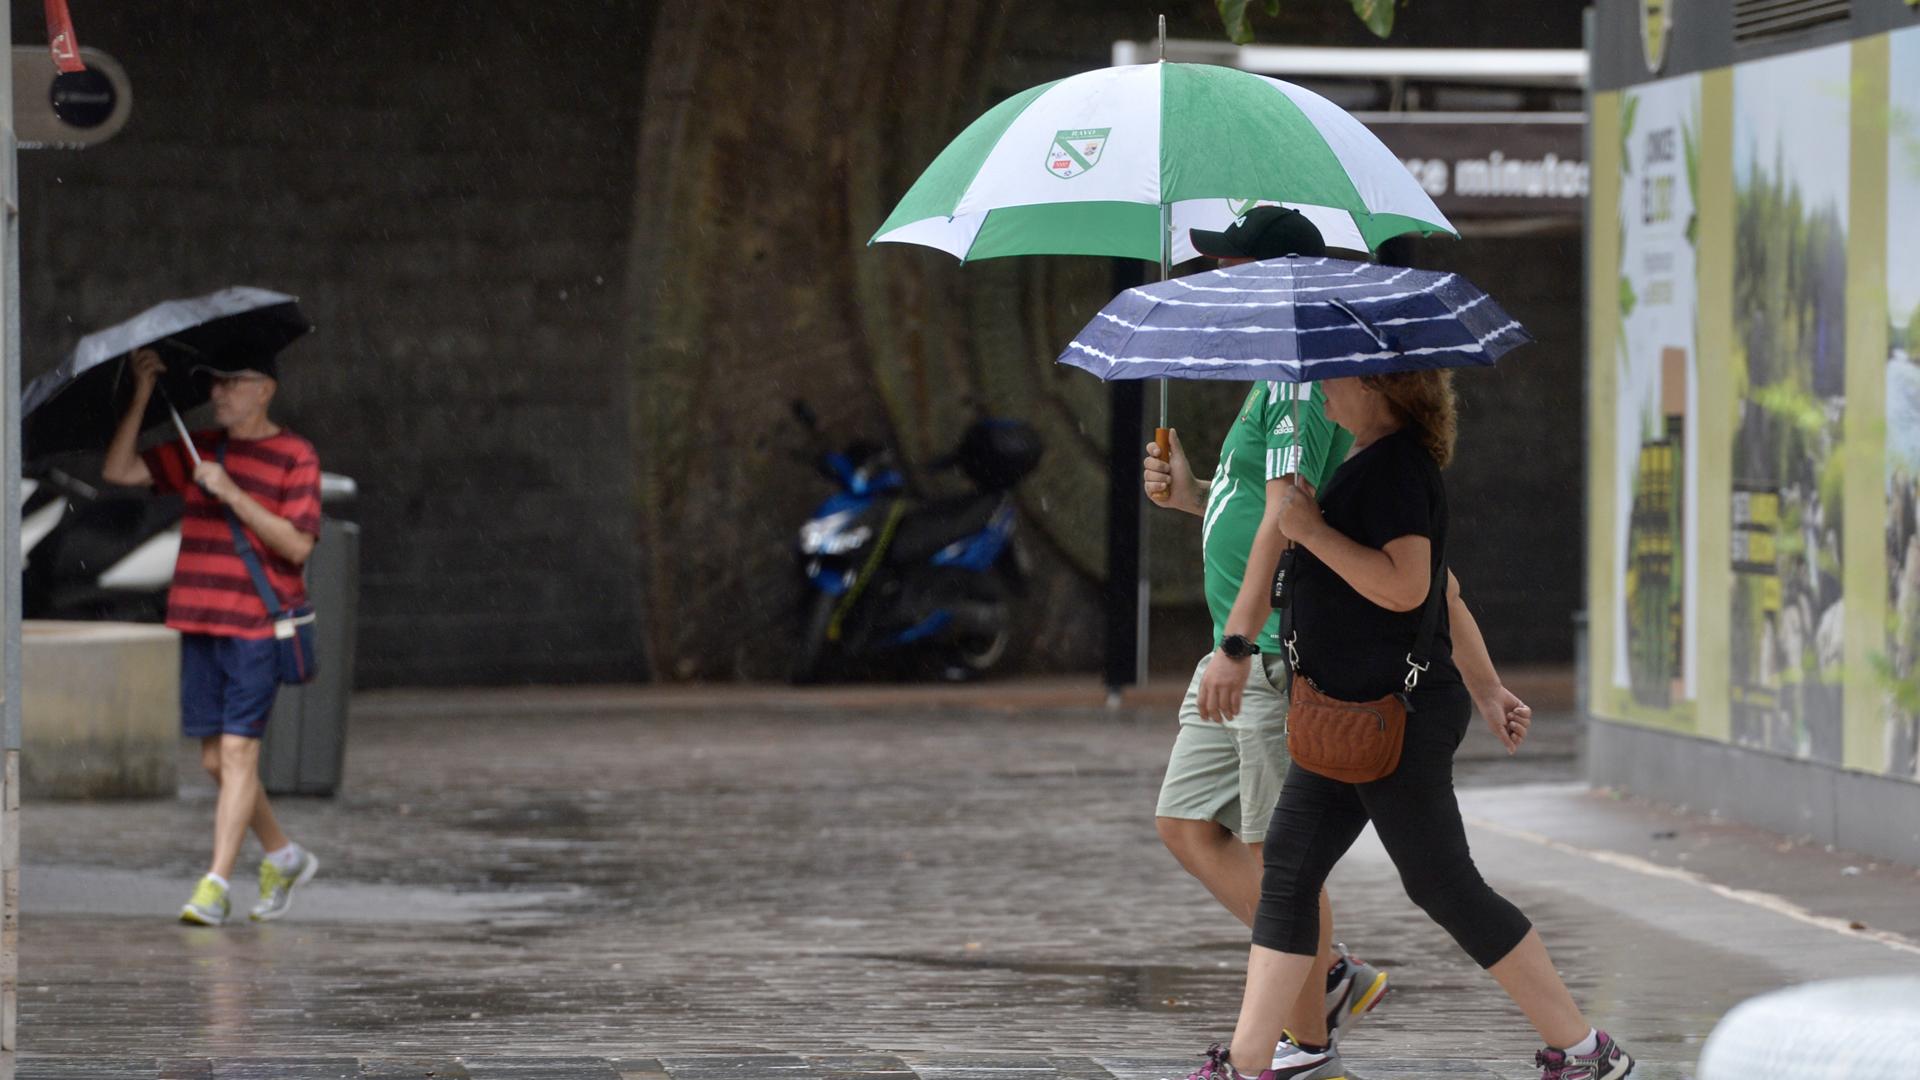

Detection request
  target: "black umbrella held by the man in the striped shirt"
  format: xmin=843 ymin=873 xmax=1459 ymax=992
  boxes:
xmin=21 ymin=286 xmax=313 ymax=463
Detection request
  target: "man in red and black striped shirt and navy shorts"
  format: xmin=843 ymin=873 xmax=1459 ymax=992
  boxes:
xmin=102 ymin=348 xmax=321 ymax=926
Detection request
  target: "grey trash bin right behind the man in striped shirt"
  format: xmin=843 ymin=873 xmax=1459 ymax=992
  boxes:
xmin=259 ymin=503 xmax=359 ymax=796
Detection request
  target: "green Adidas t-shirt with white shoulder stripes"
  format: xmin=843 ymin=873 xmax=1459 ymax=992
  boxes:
xmin=1200 ymin=382 xmax=1354 ymax=653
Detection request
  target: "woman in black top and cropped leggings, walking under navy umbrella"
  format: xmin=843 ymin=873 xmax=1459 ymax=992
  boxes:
xmin=1188 ymin=371 xmax=1634 ymax=1080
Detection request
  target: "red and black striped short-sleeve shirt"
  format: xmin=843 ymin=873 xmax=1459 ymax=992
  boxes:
xmin=142 ymin=429 xmax=321 ymax=638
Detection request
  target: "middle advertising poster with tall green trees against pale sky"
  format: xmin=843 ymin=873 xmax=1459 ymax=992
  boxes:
xmin=1730 ymin=44 xmax=1853 ymax=765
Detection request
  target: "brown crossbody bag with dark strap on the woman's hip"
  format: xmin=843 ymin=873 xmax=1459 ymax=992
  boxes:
xmin=1286 ymin=503 xmax=1446 ymax=784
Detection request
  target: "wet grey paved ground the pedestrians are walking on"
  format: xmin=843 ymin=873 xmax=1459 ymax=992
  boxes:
xmin=21 ymin=684 xmax=1920 ymax=1080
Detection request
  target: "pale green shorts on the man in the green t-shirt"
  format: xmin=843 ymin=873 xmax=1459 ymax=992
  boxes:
xmin=1154 ymin=653 xmax=1290 ymax=844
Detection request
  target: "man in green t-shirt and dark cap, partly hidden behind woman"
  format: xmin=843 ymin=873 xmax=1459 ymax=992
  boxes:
xmin=1144 ymin=206 xmax=1386 ymax=1078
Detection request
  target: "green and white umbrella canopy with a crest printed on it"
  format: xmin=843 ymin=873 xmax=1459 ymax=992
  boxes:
xmin=874 ymin=61 xmax=1453 ymax=265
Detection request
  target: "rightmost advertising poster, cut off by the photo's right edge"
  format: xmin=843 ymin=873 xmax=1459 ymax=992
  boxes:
xmin=1885 ymin=29 xmax=1920 ymax=778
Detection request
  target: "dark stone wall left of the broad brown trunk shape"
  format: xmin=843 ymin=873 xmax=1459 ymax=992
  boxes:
xmin=13 ymin=0 xmax=645 ymax=684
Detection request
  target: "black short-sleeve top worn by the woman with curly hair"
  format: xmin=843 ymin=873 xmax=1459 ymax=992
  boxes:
xmin=1292 ymin=429 xmax=1461 ymax=701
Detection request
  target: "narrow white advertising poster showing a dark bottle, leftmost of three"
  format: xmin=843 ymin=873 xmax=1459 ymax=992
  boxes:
xmin=1613 ymin=77 xmax=1699 ymax=711
